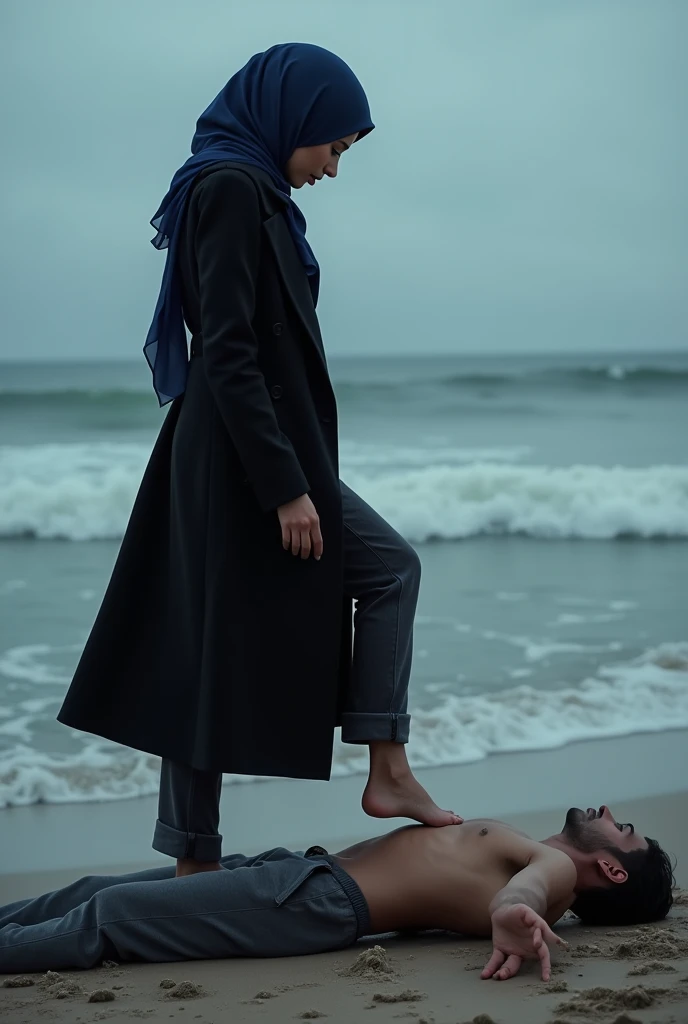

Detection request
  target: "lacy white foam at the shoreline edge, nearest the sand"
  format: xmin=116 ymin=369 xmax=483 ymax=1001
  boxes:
xmin=0 ymin=643 xmax=688 ymax=807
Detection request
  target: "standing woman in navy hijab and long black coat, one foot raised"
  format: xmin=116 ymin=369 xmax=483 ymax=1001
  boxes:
xmin=58 ymin=43 xmax=461 ymax=874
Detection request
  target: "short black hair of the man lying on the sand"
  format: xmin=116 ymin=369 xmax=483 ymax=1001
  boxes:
xmin=571 ymin=836 xmax=675 ymax=925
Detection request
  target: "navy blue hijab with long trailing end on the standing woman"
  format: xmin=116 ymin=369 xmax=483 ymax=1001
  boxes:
xmin=143 ymin=43 xmax=375 ymax=406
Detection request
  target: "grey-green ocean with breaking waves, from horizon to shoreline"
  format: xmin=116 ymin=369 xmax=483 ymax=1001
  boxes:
xmin=0 ymin=352 xmax=688 ymax=806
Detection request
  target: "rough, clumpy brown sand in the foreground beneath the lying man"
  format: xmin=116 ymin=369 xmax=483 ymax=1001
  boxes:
xmin=0 ymin=794 xmax=688 ymax=1024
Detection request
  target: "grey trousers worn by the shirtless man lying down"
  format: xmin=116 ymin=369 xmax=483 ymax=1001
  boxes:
xmin=0 ymin=847 xmax=370 ymax=974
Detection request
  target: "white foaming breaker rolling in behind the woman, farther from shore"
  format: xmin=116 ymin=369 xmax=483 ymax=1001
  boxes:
xmin=0 ymin=443 xmax=688 ymax=543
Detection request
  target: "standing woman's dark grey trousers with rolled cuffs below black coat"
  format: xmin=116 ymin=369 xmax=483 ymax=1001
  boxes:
xmin=153 ymin=481 xmax=421 ymax=860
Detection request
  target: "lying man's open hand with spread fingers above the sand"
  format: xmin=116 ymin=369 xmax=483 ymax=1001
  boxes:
xmin=480 ymin=903 xmax=566 ymax=981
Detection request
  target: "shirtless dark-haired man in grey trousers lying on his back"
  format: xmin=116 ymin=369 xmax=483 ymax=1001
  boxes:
xmin=0 ymin=806 xmax=674 ymax=981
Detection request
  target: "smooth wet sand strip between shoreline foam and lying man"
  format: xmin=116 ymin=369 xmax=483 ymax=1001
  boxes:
xmin=0 ymin=729 xmax=688 ymax=880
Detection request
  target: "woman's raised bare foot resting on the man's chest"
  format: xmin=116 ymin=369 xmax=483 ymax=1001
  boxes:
xmin=361 ymin=742 xmax=464 ymax=827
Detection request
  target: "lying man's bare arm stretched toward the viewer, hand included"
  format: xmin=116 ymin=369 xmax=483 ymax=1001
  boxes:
xmin=481 ymin=844 xmax=576 ymax=981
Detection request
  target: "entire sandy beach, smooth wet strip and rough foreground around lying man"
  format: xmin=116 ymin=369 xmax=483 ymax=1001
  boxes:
xmin=0 ymin=731 xmax=688 ymax=1024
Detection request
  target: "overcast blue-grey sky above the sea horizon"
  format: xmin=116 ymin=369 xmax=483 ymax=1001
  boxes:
xmin=0 ymin=0 xmax=688 ymax=358
